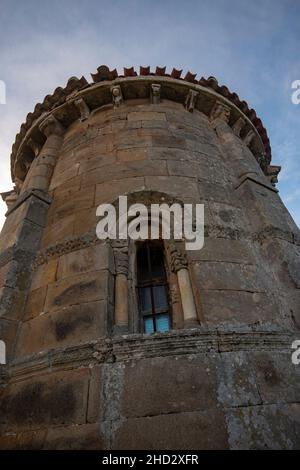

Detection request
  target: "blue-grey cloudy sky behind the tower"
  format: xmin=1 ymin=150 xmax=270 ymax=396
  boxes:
xmin=0 ymin=0 xmax=300 ymax=231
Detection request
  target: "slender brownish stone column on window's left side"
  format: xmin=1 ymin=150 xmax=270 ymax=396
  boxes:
xmin=113 ymin=241 xmax=128 ymax=334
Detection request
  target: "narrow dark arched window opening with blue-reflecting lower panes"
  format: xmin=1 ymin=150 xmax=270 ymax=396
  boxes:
xmin=137 ymin=242 xmax=171 ymax=334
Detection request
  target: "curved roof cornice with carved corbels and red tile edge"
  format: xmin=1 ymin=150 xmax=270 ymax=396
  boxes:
xmin=11 ymin=65 xmax=271 ymax=181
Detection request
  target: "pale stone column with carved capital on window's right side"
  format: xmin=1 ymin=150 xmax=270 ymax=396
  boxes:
xmin=170 ymin=244 xmax=199 ymax=327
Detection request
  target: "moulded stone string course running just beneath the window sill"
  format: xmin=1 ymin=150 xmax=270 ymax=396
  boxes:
xmin=7 ymin=326 xmax=297 ymax=382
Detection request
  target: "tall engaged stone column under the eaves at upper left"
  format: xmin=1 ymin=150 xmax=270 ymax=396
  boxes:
xmin=22 ymin=115 xmax=65 ymax=192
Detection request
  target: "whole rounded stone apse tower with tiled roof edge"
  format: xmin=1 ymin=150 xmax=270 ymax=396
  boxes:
xmin=0 ymin=66 xmax=300 ymax=449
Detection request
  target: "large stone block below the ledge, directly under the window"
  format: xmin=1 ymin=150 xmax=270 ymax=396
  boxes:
xmin=121 ymin=356 xmax=217 ymax=417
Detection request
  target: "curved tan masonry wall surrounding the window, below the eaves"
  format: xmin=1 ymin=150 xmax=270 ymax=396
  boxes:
xmin=0 ymin=95 xmax=300 ymax=449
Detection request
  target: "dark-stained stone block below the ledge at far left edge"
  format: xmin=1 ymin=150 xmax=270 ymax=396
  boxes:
xmin=0 ymin=369 xmax=89 ymax=432
